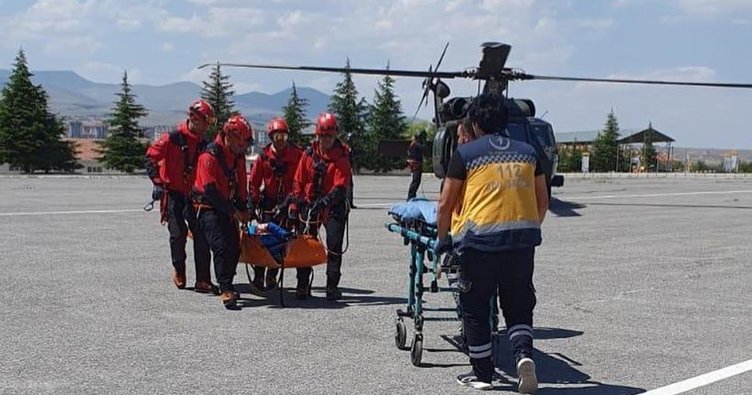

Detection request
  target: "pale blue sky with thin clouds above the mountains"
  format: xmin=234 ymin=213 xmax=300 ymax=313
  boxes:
xmin=0 ymin=0 xmax=752 ymax=149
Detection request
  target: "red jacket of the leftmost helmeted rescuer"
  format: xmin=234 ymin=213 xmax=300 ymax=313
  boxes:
xmin=146 ymin=121 xmax=204 ymax=195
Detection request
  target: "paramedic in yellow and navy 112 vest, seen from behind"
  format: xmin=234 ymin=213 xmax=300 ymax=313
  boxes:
xmin=437 ymin=94 xmax=548 ymax=393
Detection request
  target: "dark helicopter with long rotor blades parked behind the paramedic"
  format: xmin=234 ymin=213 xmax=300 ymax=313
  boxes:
xmin=198 ymin=42 xmax=752 ymax=195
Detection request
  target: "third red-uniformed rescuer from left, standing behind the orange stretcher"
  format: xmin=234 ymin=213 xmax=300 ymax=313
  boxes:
xmin=248 ymin=118 xmax=303 ymax=291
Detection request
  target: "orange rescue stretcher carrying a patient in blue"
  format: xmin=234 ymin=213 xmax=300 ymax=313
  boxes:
xmin=239 ymin=213 xmax=327 ymax=307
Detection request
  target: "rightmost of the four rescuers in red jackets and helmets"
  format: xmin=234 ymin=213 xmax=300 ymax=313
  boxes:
xmin=288 ymin=113 xmax=352 ymax=300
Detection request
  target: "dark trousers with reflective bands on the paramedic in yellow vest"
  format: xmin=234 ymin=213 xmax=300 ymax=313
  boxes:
xmin=460 ymin=248 xmax=536 ymax=383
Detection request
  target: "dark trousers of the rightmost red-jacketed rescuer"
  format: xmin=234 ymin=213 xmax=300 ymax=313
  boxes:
xmin=298 ymin=202 xmax=348 ymax=288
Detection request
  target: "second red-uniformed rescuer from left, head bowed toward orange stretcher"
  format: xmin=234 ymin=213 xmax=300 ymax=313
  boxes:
xmin=192 ymin=115 xmax=253 ymax=309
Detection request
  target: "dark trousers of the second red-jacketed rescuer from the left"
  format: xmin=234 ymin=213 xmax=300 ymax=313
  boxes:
xmin=198 ymin=208 xmax=240 ymax=292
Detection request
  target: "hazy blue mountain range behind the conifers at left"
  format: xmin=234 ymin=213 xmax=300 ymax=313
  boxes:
xmin=0 ymin=69 xmax=329 ymax=126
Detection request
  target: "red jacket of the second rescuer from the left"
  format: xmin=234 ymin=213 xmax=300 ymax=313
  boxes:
xmin=193 ymin=136 xmax=248 ymax=215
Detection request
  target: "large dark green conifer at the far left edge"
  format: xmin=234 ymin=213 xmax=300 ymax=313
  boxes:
xmin=0 ymin=50 xmax=78 ymax=173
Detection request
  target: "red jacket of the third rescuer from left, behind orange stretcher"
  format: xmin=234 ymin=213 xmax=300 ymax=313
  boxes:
xmin=248 ymin=143 xmax=303 ymax=209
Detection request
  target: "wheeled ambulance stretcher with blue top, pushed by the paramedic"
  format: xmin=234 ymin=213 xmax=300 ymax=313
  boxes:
xmin=385 ymin=198 xmax=499 ymax=366
